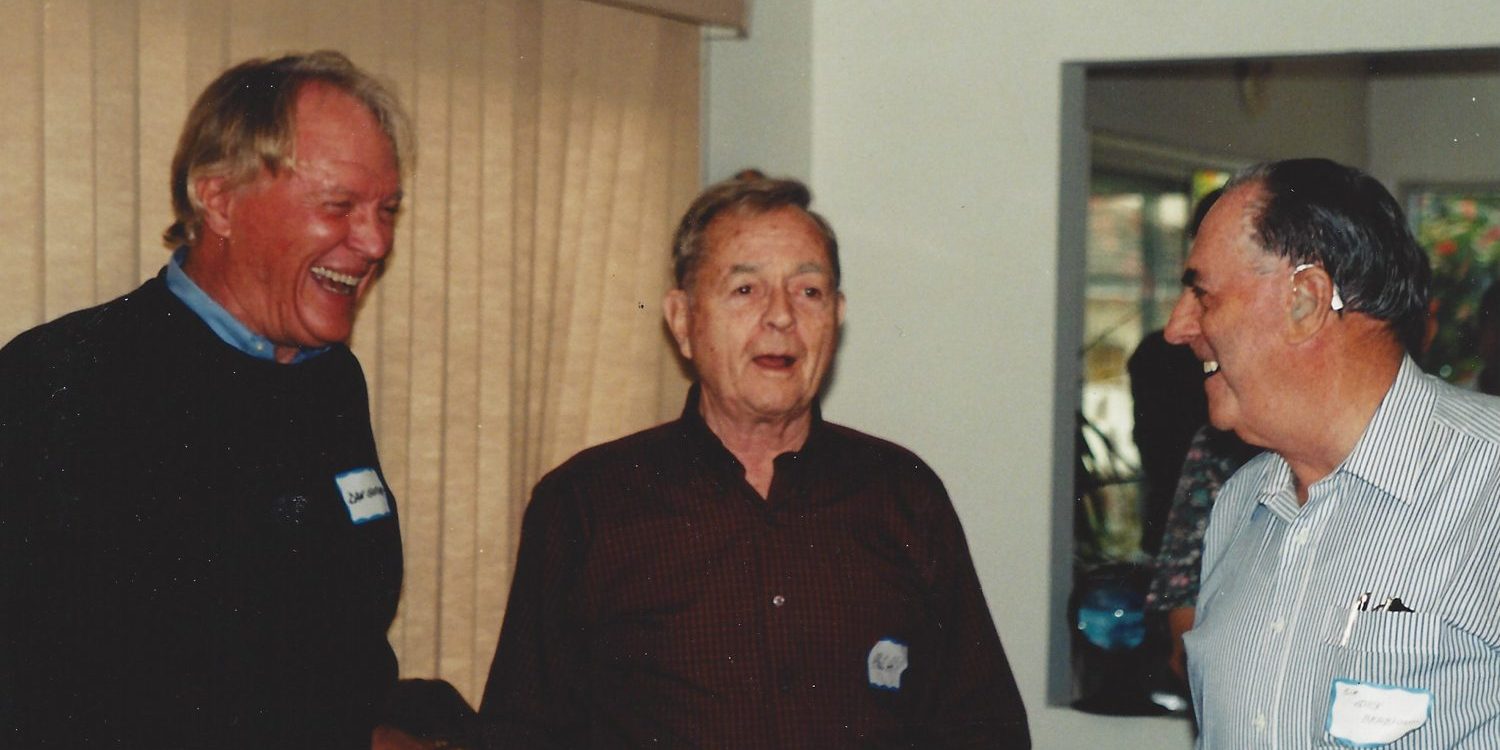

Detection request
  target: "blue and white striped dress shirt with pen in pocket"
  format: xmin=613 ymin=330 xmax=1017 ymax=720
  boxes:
xmin=1187 ymin=359 xmax=1500 ymax=749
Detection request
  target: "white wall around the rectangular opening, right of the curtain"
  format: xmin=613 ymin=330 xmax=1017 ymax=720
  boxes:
xmin=707 ymin=0 xmax=1500 ymax=749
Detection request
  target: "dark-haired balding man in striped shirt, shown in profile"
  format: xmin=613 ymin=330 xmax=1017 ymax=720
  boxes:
xmin=1167 ymin=159 xmax=1500 ymax=749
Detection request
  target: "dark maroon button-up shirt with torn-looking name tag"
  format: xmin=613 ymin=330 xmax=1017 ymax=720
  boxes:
xmin=480 ymin=387 xmax=1029 ymax=750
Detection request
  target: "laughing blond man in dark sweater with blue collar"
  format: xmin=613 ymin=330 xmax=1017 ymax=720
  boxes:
xmin=0 ymin=53 xmax=405 ymax=750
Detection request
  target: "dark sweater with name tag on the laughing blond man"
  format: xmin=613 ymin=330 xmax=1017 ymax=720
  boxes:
xmin=0 ymin=279 xmax=402 ymax=749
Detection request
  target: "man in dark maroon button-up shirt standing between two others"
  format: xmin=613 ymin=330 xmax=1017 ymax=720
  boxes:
xmin=480 ymin=173 xmax=1031 ymax=750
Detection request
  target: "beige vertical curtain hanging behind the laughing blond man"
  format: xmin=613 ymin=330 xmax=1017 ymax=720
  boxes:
xmin=0 ymin=0 xmax=699 ymax=702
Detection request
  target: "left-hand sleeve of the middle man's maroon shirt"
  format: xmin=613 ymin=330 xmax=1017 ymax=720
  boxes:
xmin=479 ymin=476 xmax=588 ymax=750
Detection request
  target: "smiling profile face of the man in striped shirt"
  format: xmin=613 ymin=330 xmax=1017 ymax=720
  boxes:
xmin=1166 ymin=185 xmax=1292 ymax=446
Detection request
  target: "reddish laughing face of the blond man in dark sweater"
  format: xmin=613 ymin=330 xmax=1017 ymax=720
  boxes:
xmin=186 ymin=83 xmax=401 ymax=362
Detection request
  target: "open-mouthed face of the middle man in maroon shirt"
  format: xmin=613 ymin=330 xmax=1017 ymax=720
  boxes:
xmin=666 ymin=207 xmax=843 ymax=426
